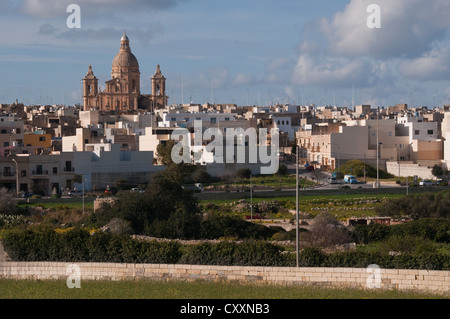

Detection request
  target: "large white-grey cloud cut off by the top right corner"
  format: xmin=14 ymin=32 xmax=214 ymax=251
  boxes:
xmin=320 ymin=0 xmax=450 ymax=58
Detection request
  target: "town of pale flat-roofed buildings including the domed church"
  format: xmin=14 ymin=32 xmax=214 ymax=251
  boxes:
xmin=0 ymin=34 xmax=450 ymax=195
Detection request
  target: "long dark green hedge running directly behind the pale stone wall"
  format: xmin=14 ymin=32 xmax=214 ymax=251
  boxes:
xmin=2 ymin=228 xmax=450 ymax=270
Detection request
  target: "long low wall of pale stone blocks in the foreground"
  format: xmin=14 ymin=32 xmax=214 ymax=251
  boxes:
xmin=0 ymin=262 xmax=450 ymax=295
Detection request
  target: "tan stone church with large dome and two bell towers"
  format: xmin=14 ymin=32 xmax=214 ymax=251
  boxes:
xmin=83 ymin=32 xmax=168 ymax=112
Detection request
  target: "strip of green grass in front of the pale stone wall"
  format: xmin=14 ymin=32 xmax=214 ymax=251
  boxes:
xmin=0 ymin=280 xmax=448 ymax=300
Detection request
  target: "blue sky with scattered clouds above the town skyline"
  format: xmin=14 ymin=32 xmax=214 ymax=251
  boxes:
xmin=0 ymin=0 xmax=450 ymax=106
